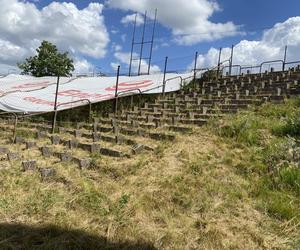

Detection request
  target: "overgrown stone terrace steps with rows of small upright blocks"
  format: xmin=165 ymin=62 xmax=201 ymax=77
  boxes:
xmin=0 ymin=67 xmax=300 ymax=176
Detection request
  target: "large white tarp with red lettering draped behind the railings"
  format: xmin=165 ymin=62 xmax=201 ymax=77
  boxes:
xmin=0 ymin=73 xmax=193 ymax=113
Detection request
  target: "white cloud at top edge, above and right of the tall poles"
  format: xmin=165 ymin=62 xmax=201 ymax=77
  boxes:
xmin=107 ymin=0 xmax=238 ymax=45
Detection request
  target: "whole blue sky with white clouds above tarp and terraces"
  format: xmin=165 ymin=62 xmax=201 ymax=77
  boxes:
xmin=0 ymin=0 xmax=300 ymax=73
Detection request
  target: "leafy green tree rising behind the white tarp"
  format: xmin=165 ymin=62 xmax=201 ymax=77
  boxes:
xmin=18 ymin=41 xmax=74 ymax=77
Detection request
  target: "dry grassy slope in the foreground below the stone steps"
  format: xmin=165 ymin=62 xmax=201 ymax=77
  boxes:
xmin=0 ymin=99 xmax=300 ymax=249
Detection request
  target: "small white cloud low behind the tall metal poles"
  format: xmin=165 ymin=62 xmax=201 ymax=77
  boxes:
xmin=111 ymin=51 xmax=161 ymax=74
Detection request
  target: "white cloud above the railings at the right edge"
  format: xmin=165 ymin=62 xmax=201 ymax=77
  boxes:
xmin=198 ymin=16 xmax=300 ymax=72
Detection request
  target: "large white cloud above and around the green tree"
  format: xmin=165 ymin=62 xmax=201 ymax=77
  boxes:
xmin=0 ymin=0 xmax=109 ymax=72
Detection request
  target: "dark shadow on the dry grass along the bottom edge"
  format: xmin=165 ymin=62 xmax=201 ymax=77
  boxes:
xmin=0 ymin=224 xmax=155 ymax=250
